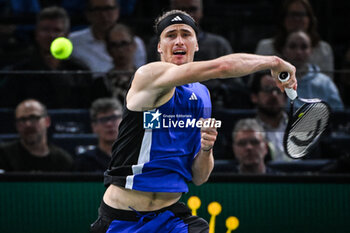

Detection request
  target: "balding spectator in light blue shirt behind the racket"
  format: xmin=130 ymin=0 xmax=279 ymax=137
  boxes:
xmin=283 ymin=31 xmax=344 ymax=110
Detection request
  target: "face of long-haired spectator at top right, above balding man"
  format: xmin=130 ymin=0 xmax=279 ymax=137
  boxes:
xmin=284 ymin=2 xmax=310 ymax=32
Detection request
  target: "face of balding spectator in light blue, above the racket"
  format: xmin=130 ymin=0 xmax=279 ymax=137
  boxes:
xmin=283 ymin=31 xmax=312 ymax=68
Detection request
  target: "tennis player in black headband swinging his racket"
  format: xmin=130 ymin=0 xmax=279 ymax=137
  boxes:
xmin=91 ymin=10 xmax=297 ymax=233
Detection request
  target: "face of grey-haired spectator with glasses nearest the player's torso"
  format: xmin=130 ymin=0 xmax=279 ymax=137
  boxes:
xmin=92 ymin=110 xmax=121 ymax=143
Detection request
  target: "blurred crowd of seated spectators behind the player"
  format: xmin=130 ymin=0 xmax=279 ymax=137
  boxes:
xmin=0 ymin=0 xmax=350 ymax=174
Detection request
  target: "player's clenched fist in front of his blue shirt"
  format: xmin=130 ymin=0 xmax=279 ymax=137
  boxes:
xmin=200 ymin=118 xmax=218 ymax=151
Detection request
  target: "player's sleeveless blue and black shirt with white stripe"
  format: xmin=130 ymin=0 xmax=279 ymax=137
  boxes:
xmin=105 ymin=83 xmax=211 ymax=192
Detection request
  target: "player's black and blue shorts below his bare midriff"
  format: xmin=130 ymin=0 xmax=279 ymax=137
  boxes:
xmin=90 ymin=201 xmax=209 ymax=233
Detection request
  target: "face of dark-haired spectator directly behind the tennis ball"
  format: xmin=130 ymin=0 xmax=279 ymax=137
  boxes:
xmin=35 ymin=19 xmax=67 ymax=52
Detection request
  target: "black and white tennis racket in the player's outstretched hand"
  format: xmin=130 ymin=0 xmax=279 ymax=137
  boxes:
xmin=278 ymin=72 xmax=331 ymax=159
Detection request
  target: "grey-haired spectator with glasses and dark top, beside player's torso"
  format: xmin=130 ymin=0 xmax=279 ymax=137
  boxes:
xmin=74 ymin=98 xmax=122 ymax=173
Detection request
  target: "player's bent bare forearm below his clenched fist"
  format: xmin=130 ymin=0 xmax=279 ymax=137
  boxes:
xmin=192 ymin=149 xmax=214 ymax=185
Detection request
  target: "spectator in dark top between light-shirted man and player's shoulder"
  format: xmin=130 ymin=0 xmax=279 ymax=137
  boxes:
xmin=91 ymin=24 xmax=136 ymax=103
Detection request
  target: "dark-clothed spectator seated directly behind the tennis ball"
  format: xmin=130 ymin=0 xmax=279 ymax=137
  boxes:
xmin=1 ymin=7 xmax=91 ymax=108
